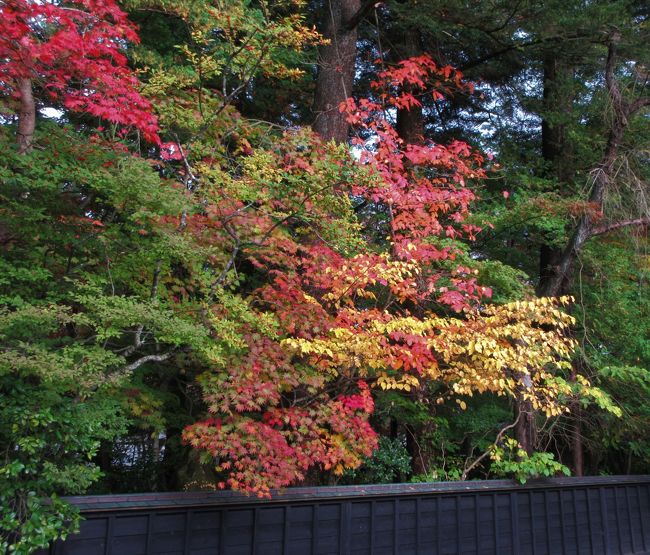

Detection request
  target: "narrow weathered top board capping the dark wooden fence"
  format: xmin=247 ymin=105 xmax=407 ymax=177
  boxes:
xmin=64 ymin=475 xmax=650 ymax=513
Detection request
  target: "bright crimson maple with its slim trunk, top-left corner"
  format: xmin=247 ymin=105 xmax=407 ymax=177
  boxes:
xmin=0 ymin=0 xmax=158 ymax=153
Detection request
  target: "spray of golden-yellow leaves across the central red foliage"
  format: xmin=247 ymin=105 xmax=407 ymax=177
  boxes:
xmin=284 ymin=296 xmax=605 ymax=416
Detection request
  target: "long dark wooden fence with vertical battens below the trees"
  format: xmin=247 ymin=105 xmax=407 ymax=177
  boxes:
xmin=36 ymin=476 xmax=650 ymax=555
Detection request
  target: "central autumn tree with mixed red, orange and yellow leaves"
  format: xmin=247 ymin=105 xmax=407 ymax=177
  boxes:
xmin=184 ymin=56 xmax=607 ymax=495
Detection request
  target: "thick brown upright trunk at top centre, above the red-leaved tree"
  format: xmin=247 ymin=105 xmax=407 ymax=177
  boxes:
xmin=312 ymin=0 xmax=361 ymax=143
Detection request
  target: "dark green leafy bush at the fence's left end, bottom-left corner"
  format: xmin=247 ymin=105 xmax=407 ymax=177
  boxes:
xmin=0 ymin=344 xmax=124 ymax=554
